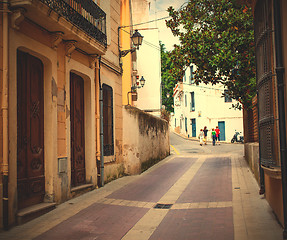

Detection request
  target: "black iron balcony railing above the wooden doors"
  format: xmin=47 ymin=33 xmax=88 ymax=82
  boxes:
xmin=40 ymin=0 xmax=107 ymax=47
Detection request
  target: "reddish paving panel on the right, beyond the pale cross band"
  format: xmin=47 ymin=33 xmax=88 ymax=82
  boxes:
xmin=177 ymin=158 xmax=232 ymax=203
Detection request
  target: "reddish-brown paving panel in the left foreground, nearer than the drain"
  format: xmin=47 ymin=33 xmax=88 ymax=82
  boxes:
xmin=35 ymin=203 xmax=148 ymax=240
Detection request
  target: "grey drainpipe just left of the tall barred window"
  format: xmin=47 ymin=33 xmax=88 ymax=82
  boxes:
xmin=99 ymin=57 xmax=104 ymax=187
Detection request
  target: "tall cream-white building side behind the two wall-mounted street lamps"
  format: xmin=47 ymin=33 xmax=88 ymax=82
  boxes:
xmin=132 ymin=0 xmax=161 ymax=116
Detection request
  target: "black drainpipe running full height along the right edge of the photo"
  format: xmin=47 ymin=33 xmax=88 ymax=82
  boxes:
xmin=273 ymin=0 xmax=287 ymax=239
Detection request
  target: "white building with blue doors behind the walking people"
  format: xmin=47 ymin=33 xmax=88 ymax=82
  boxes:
xmin=171 ymin=65 xmax=243 ymax=142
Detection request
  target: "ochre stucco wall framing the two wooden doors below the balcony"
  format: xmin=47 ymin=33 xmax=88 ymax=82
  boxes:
xmin=5 ymin=15 xmax=100 ymax=224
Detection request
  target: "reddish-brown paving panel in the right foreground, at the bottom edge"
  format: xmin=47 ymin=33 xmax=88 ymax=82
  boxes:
xmin=149 ymin=208 xmax=234 ymax=240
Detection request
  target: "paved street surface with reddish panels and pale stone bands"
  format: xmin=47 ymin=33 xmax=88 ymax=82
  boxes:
xmin=0 ymin=134 xmax=282 ymax=240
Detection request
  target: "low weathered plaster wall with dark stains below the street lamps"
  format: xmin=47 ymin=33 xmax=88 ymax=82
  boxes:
xmin=123 ymin=106 xmax=170 ymax=175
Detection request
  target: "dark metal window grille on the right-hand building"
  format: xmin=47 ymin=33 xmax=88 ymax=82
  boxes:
xmin=254 ymin=0 xmax=277 ymax=167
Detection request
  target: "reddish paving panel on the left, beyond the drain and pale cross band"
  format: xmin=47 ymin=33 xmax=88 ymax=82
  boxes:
xmin=108 ymin=158 xmax=196 ymax=202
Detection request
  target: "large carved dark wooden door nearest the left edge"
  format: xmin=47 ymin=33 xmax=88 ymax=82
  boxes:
xmin=17 ymin=51 xmax=45 ymax=209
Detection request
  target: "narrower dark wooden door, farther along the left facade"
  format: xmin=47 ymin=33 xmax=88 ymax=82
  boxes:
xmin=70 ymin=73 xmax=86 ymax=187
